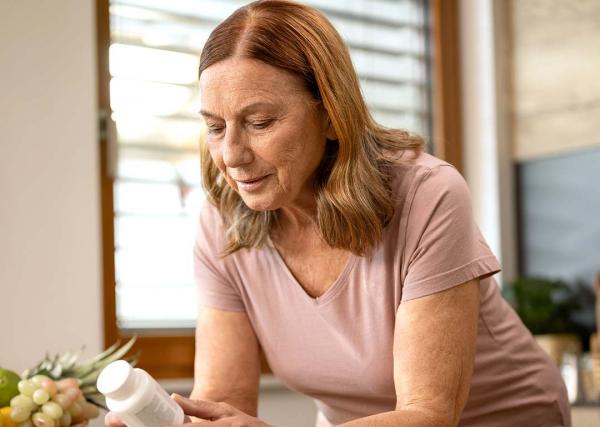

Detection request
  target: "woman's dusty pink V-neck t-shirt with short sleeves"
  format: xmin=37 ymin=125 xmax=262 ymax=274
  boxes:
xmin=194 ymin=154 xmax=570 ymax=427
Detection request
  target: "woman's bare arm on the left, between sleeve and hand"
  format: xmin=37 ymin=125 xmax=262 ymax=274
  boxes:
xmin=190 ymin=307 xmax=260 ymax=416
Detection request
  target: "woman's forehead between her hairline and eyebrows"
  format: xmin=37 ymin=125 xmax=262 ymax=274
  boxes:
xmin=200 ymin=58 xmax=311 ymax=109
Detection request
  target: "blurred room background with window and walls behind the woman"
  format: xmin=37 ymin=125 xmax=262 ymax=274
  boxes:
xmin=0 ymin=0 xmax=600 ymax=426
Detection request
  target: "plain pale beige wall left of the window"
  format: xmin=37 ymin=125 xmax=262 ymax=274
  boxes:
xmin=0 ymin=0 xmax=102 ymax=372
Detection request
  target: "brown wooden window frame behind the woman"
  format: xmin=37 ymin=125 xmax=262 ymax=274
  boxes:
xmin=96 ymin=0 xmax=462 ymax=378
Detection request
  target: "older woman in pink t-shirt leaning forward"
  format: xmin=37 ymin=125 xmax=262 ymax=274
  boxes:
xmin=108 ymin=1 xmax=570 ymax=427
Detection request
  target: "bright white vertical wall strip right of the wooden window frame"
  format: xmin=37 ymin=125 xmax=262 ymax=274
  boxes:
xmin=459 ymin=0 xmax=517 ymax=281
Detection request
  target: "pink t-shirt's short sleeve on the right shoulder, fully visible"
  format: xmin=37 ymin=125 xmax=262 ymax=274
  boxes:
xmin=402 ymin=163 xmax=500 ymax=301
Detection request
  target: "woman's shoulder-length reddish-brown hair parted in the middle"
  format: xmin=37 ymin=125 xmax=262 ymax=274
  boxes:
xmin=200 ymin=0 xmax=423 ymax=256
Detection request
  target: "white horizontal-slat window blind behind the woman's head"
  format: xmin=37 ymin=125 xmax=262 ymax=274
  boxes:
xmin=110 ymin=0 xmax=430 ymax=329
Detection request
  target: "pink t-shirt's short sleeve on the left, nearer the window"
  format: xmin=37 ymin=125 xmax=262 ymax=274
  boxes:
xmin=194 ymin=203 xmax=245 ymax=311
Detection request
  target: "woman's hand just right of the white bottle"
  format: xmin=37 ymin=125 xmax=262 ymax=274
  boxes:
xmin=170 ymin=394 xmax=272 ymax=427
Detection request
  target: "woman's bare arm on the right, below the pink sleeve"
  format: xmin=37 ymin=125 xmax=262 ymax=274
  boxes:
xmin=340 ymin=279 xmax=479 ymax=427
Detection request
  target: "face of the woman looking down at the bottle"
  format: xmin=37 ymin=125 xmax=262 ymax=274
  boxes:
xmin=200 ymin=58 xmax=335 ymax=211
